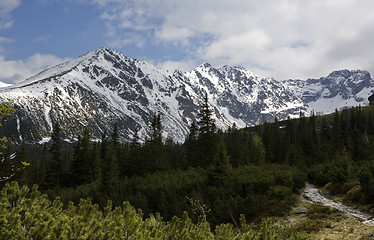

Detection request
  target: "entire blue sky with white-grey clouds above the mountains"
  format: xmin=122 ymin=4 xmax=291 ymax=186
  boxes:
xmin=0 ymin=0 xmax=374 ymax=82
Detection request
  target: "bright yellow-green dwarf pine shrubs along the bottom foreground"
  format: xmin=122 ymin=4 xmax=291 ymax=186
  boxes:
xmin=0 ymin=182 xmax=305 ymax=240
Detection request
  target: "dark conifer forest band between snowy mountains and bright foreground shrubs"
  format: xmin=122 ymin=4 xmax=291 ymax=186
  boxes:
xmin=0 ymin=100 xmax=374 ymax=231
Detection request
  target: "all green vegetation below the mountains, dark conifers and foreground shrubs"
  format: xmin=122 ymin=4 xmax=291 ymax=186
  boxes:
xmin=1 ymin=99 xmax=374 ymax=239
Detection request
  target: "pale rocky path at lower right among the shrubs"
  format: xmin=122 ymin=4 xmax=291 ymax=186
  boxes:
xmin=303 ymin=183 xmax=374 ymax=226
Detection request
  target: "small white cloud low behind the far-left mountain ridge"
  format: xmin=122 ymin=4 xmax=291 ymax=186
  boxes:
xmin=0 ymin=53 xmax=68 ymax=83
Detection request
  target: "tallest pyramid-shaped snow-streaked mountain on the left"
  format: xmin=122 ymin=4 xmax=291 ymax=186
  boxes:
xmin=0 ymin=48 xmax=194 ymax=142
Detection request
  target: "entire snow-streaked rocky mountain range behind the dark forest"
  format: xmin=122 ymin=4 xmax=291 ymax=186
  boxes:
xmin=0 ymin=48 xmax=374 ymax=142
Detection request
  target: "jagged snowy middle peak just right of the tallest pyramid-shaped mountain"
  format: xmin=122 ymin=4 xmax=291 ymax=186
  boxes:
xmin=182 ymin=64 xmax=310 ymax=127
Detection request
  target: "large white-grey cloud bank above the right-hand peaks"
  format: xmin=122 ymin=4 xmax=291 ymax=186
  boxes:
xmin=94 ymin=0 xmax=374 ymax=79
